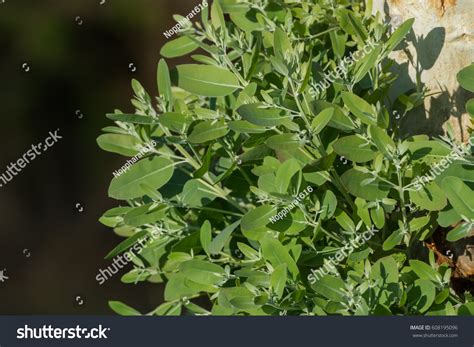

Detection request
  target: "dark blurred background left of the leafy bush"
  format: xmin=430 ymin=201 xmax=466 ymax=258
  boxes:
xmin=0 ymin=0 xmax=194 ymax=314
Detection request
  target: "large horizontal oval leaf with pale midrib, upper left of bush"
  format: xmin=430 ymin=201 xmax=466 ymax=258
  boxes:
xmin=176 ymin=64 xmax=240 ymax=97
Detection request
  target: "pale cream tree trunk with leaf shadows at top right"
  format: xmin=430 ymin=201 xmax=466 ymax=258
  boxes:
xmin=373 ymin=0 xmax=474 ymax=141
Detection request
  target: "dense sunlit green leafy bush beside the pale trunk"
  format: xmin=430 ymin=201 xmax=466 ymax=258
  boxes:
xmin=98 ymin=0 xmax=474 ymax=315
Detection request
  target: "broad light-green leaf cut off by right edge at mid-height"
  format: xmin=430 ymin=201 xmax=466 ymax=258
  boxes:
xmin=441 ymin=176 xmax=474 ymax=220
